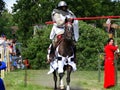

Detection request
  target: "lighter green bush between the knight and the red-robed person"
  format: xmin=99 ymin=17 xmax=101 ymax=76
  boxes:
xmin=77 ymin=22 xmax=108 ymax=70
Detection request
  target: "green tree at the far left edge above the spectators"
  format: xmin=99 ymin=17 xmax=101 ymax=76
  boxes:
xmin=0 ymin=0 xmax=12 ymax=38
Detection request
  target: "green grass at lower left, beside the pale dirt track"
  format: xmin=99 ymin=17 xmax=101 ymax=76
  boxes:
xmin=4 ymin=70 xmax=51 ymax=90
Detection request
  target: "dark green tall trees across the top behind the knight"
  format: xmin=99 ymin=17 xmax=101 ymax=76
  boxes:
xmin=13 ymin=0 xmax=120 ymax=44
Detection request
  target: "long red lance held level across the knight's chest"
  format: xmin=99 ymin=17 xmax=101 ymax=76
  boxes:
xmin=45 ymin=16 xmax=120 ymax=24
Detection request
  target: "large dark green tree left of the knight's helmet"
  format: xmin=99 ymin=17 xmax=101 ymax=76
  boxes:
xmin=13 ymin=0 xmax=56 ymax=43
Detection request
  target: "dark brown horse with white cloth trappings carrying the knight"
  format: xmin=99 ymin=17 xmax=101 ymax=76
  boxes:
xmin=53 ymin=20 xmax=76 ymax=90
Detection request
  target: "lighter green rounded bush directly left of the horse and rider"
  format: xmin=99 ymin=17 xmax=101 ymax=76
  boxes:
xmin=22 ymin=26 xmax=51 ymax=69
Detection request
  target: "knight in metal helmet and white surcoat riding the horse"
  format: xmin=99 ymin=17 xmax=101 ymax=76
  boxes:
xmin=47 ymin=1 xmax=79 ymax=62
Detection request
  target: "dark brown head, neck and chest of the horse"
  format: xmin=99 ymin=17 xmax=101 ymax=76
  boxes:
xmin=58 ymin=20 xmax=74 ymax=57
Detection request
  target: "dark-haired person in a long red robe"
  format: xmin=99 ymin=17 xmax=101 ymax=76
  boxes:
xmin=104 ymin=38 xmax=118 ymax=88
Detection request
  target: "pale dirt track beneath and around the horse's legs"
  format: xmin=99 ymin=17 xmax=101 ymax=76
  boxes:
xmin=27 ymin=70 xmax=85 ymax=90
